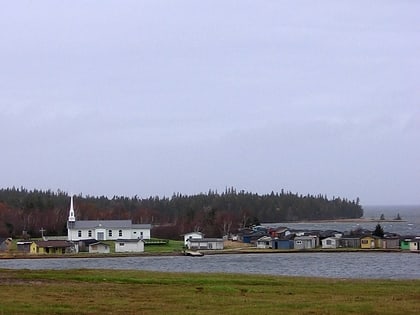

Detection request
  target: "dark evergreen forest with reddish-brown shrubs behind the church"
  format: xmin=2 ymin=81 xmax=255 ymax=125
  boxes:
xmin=0 ymin=187 xmax=363 ymax=239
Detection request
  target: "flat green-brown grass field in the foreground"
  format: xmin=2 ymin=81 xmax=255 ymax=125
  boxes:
xmin=0 ymin=270 xmax=420 ymax=315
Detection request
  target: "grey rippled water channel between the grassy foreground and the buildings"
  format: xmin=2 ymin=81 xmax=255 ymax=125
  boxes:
xmin=0 ymin=252 xmax=420 ymax=279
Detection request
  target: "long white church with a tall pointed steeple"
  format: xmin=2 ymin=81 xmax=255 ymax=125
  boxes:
xmin=67 ymin=196 xmax=152 ymax=241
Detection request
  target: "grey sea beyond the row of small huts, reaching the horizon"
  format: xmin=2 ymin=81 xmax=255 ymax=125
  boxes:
xmin=264 ymin=205 xmax=420 ymax=236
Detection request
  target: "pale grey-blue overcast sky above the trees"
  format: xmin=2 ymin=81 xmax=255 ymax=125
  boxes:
xmin=0 ymin=0 xmax=420 ymax=205
